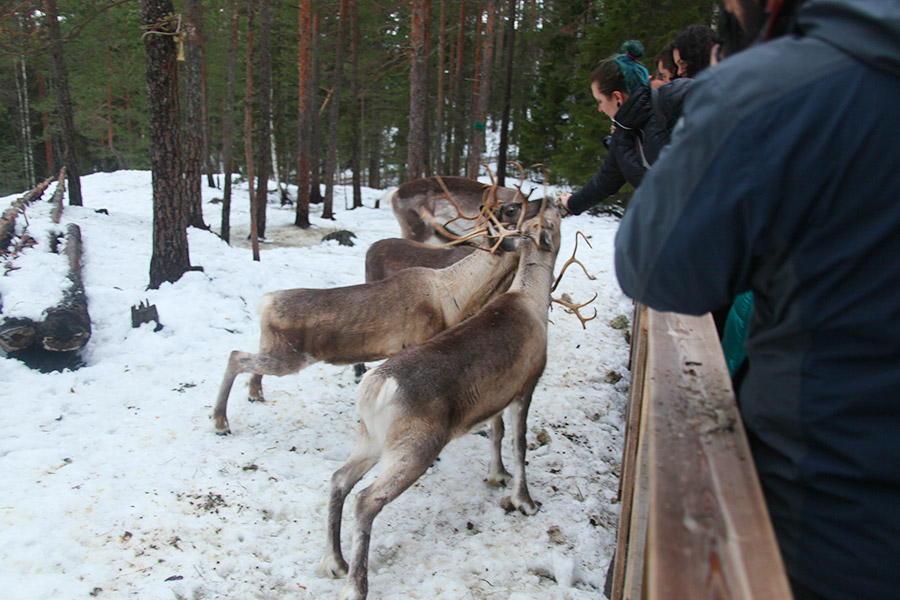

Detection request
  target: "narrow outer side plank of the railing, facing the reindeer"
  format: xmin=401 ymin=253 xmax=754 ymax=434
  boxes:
xmin=610 ymin=304 xmax=647 ymax=600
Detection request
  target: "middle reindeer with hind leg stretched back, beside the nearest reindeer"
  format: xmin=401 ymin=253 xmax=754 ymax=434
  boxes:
xmin=213 ymin=227 xmax=519 ymax=435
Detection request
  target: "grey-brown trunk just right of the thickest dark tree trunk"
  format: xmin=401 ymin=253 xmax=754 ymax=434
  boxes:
xmin=183 ymin=0 xmax=208 ymax=229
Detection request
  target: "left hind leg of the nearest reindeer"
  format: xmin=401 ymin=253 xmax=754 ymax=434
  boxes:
xmin=316 ymin=423 xmax=380 ymax=579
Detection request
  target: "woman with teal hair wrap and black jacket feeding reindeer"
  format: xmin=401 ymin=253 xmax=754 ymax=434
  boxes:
xmin=558 ymin=40 xmax=691 ymax=215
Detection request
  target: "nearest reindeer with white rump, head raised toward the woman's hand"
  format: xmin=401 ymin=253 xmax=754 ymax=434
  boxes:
xmin=317 ymin=203 xmax=560 ymax=600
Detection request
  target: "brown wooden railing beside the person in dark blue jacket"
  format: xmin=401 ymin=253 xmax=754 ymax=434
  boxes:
xmin=610 ymin=306 xmax=791 ymax=600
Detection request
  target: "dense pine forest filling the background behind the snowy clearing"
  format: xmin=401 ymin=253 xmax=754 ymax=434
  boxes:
xmin=0 ymin=0 xmax=719 ymax=212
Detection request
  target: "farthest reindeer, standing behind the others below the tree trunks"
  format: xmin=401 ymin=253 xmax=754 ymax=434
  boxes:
xmin=391 ymin=176 xmax=527 ymax=245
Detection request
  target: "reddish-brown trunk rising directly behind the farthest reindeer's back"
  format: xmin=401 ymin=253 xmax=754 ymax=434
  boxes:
xmin=406 ymin=0 xmax=428 ymax=181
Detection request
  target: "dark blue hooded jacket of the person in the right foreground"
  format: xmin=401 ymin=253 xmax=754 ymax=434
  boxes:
xmin=616 ymin=0 xmax=900 ymax=600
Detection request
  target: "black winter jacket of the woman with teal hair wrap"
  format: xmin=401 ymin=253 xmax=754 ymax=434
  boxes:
xmin=568 ymin=79 xmax=693 ymax=215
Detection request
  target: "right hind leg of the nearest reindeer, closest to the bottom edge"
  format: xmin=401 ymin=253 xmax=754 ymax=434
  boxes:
xmin=340 ymin=434 xmax=443 ymax=600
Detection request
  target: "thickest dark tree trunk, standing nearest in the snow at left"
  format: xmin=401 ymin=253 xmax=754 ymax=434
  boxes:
xmin=141 ymin=0 xmax=191 ymax=289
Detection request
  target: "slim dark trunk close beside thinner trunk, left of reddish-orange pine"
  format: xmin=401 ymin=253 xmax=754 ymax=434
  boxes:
xmin=256 ymin=0 xmax=272 ymax=238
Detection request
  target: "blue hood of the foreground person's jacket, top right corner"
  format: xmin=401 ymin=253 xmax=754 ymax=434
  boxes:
xmin=796 ymin=0 xmax=900 ymax=75
